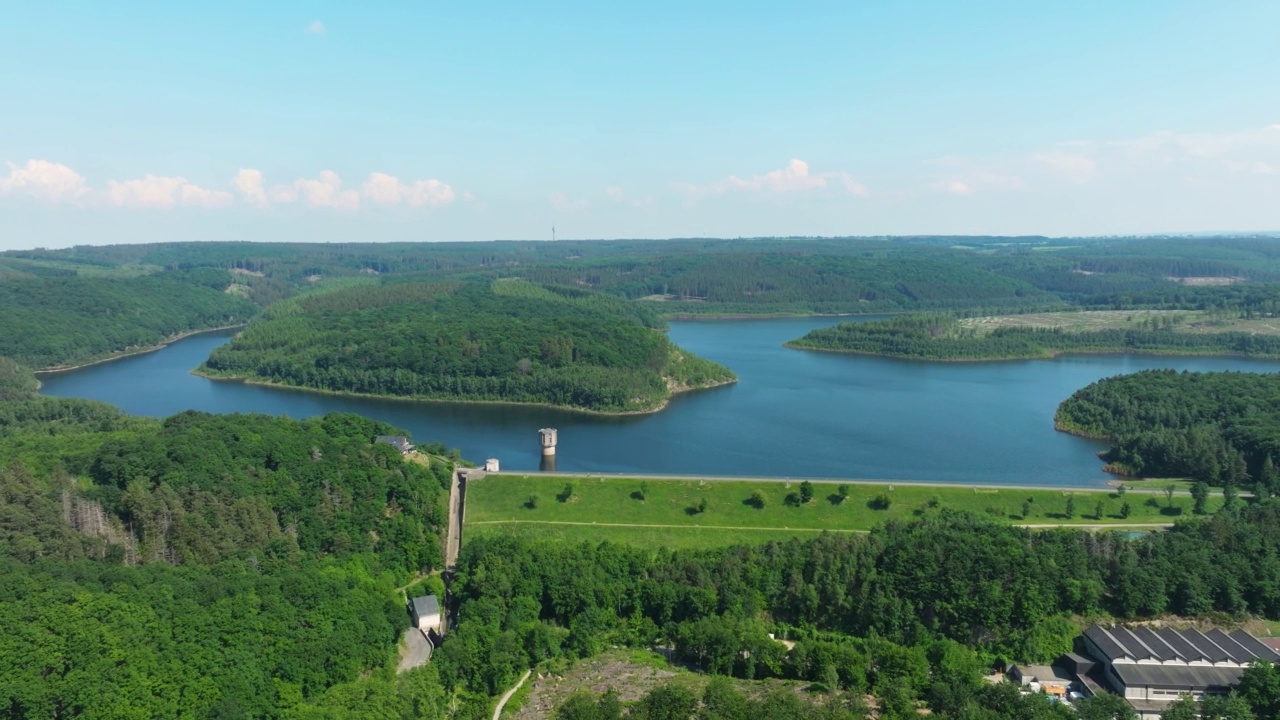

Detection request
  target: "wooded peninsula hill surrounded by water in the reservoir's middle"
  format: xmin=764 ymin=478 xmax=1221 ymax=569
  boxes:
xmin=202 ymin=279 xmax=733 ymax=411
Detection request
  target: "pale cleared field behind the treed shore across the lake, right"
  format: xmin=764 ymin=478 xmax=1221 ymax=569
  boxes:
xmin=960 ymin=310 xmax=1280 ymax=334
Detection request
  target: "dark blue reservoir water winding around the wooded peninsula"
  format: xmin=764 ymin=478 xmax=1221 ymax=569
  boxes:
xmin=41 ymin=318 xmax=1280 ymax=486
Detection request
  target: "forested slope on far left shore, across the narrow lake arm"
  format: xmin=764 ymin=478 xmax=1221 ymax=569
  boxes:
xmin=0 ymin=273 xmax=257 ymax=369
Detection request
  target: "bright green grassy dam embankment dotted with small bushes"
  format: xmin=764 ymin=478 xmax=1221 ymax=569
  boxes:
xmin=465 ymin=474 xmax=1221 ymax=547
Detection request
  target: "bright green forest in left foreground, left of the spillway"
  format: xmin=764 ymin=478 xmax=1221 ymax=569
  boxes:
xmin=0 ymin=363 xmax=460 ymax=719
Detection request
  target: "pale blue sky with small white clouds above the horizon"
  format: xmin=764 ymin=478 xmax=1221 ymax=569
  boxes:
xmin=0 ymin=0 xmax=1280 ymax=249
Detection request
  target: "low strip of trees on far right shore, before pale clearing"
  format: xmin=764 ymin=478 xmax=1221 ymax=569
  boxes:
xmin=787 ymin=315 xmax=1280 ymax=360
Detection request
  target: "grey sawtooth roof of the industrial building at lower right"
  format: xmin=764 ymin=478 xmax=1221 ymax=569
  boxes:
xmin=1084 ymin=625 xmax=1280 ymax=665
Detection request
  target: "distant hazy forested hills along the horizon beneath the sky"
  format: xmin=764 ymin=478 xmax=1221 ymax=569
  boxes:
xmin=12 ymin=236 xmax=1280 ymax=315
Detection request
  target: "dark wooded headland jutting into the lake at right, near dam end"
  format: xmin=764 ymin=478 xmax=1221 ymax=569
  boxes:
xmin=1055 ymin=370 xmax=1280 ymax=481
